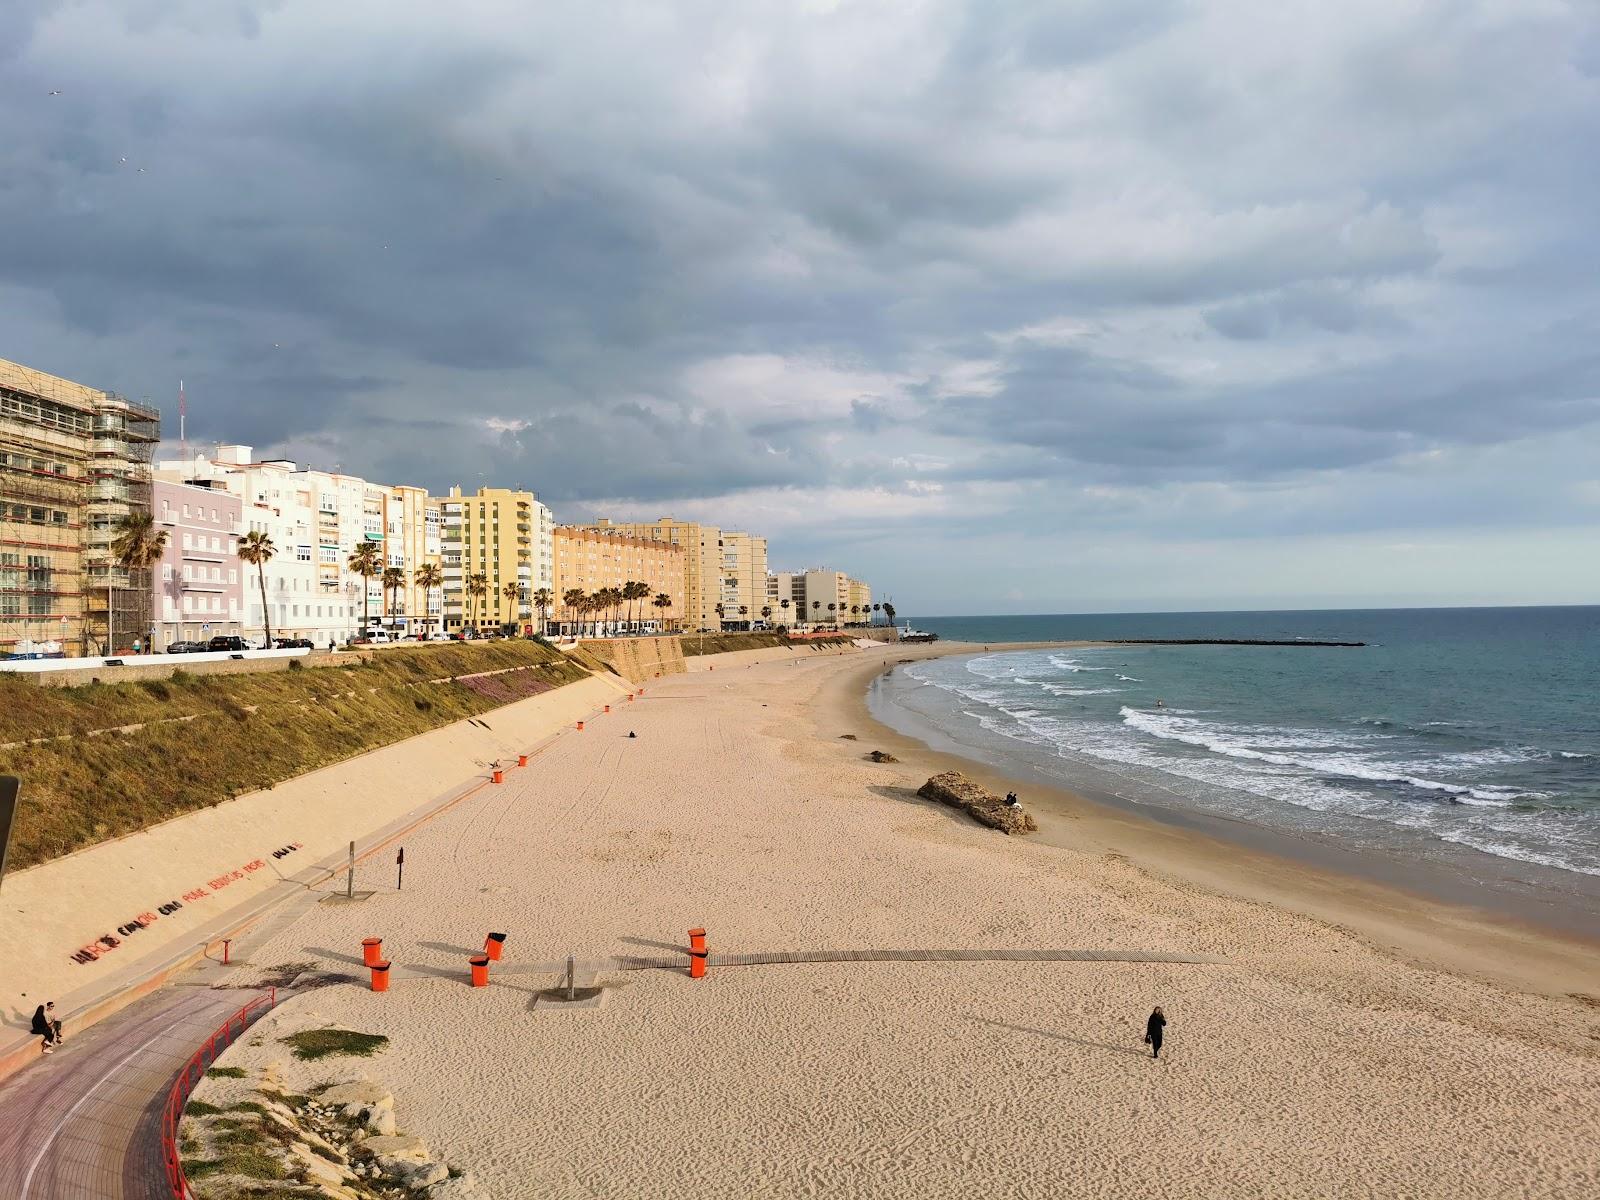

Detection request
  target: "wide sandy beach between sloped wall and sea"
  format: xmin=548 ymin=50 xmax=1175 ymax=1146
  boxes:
xmin=229 ymin=646 xmax=1600 ymax=1197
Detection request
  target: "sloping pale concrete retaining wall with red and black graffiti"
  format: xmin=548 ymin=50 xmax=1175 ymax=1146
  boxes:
xmin=0 ymin=677 xmax=626 ymax=1067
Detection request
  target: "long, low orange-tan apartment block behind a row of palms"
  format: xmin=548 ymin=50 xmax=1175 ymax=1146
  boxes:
xmin=549 ymin=525 xmax=685 ymax=634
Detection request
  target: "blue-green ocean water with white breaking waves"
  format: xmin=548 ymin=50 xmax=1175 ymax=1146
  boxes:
xmin=874 ymin=608 xmax=1600 ymax=883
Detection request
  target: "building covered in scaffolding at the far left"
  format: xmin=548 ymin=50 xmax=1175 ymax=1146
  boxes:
xmin=0 ymin=358 xmax=160 ymax=654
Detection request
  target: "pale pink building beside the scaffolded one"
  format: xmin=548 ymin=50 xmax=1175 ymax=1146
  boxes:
xmin=150 ymin=480 xmax=245 ymax=650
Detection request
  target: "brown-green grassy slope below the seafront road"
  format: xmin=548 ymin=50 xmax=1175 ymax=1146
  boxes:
xmin=0 ymin=642 xmax=586 ymax=869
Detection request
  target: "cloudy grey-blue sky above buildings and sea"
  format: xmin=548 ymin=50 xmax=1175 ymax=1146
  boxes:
xmin=0 ymin=0 xmax=1600 ymax=614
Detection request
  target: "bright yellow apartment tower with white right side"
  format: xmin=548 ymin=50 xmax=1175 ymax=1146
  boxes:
xmin=438 ymin=486 xmax=555 ymax=634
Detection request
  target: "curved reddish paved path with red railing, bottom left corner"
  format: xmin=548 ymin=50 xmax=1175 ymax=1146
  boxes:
xmin=0 ymin=986 xmax=251 ymax=1200
